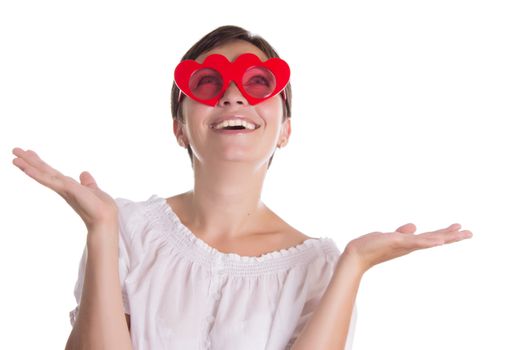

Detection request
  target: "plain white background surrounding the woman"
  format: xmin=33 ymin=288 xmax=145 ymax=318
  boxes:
xmin=0 ymin=0 xmax=525 ymax=350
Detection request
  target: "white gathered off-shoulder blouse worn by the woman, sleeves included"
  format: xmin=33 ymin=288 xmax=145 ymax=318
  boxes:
xmin=70 ymin=195 xmax=356 ymax=350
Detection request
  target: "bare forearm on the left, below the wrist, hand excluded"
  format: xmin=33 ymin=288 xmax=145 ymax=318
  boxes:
xmin=66 ymin=222 xmax=132 ymax=350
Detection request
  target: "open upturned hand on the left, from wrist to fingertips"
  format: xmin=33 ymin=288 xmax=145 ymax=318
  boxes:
xmin=13 ymin=147 xmax=118 ymax=231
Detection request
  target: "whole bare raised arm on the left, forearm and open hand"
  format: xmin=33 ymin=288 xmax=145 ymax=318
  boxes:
xmin=13 ymin=147 xmax=132 ymax=350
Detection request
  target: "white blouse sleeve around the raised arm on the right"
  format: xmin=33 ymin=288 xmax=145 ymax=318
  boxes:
xmin=286 ymin=254 xmax=357 ymax=350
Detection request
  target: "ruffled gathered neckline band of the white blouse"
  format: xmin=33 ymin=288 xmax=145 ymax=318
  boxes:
xmin=148 ymin=194 xmax=338 ymax=263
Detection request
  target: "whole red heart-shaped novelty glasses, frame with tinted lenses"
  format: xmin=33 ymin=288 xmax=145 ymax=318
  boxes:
xmin=174 ymin=53 xmax=290 ymax=106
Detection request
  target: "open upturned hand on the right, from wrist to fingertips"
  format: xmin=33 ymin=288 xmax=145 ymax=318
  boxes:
xmin=343 ymin=223 xmax=472 ymax=273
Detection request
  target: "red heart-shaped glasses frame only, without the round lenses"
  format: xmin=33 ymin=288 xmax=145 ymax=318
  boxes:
xmin=174 ymin=53 xmax=290 ymax=106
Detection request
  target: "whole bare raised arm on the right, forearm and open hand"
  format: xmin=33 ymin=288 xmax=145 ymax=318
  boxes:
xmin=291 ymin=224 xmax=472 ymax=350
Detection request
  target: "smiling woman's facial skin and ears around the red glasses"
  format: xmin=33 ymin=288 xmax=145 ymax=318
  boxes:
xmin=174 ymin=40 xmax=291 ymax=168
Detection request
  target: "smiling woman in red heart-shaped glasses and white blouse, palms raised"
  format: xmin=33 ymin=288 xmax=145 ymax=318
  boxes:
xmin=13 ymin=26 xmax=472 ymax=349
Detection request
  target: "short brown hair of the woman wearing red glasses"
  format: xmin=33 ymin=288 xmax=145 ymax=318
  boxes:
xmin=171 ymin=25 xmax=292 ymax=168
